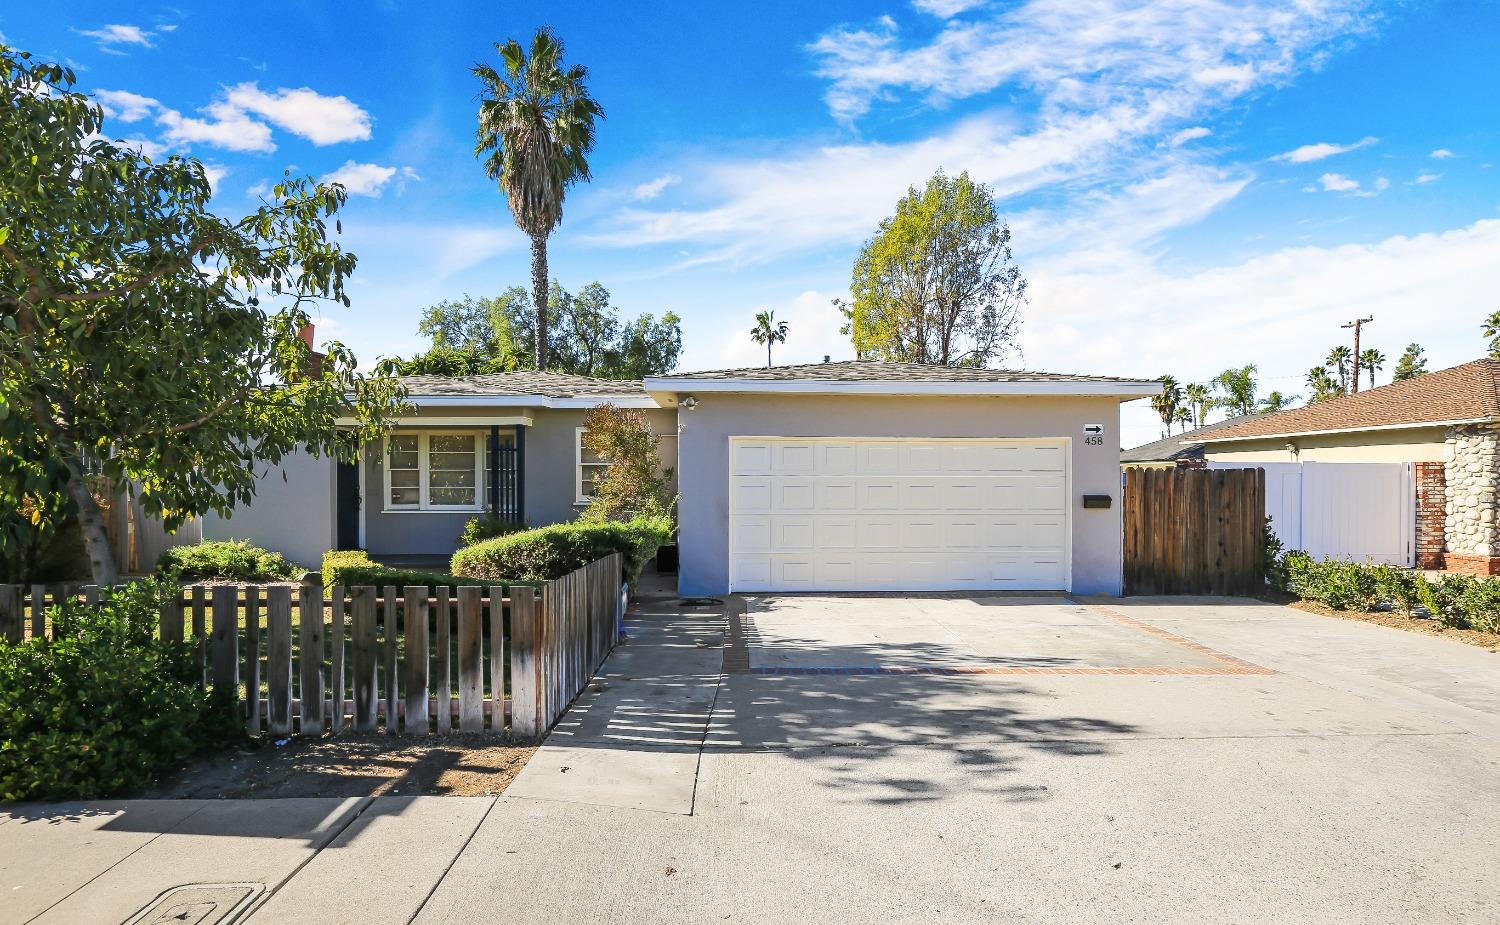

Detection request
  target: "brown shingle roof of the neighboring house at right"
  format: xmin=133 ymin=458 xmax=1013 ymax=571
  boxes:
xmin=1208 ymin=358 xmax=1500 ymax=442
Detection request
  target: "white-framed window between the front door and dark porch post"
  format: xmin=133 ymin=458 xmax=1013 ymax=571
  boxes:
xmin=384 ymin=430 xmax=485 ymax=511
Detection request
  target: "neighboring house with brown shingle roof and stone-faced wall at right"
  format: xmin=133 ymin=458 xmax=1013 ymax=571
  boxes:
xmin=1196 ymin=360 xmax=1500 ymax=574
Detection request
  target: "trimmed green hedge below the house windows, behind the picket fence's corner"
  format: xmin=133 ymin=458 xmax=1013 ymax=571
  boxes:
xmin=453 ymin=516 xmax=672 ymax=583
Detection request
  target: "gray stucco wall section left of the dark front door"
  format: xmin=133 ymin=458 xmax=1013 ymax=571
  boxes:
xmin=201 ymin=450 xmax=335 ymax=568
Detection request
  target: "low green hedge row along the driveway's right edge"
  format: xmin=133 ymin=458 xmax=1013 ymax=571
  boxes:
xmin=1274 ymin=552 xmax=1500 ymax=633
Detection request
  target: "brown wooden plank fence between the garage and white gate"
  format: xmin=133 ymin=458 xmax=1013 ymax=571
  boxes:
xmin=1125 ymin=468 xmax=1266 ymax=595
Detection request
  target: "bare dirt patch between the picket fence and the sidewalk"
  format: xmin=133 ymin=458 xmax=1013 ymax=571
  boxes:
xmin=141 ymin=733 xmax=537 ymax=799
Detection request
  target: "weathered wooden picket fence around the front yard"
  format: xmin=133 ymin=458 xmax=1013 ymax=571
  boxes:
xmin=0 ymin=553 xmax=623 ymax=736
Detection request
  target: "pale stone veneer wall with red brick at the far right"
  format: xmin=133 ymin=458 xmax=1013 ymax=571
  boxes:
xmin=1443 ymin=424 xmax=1500 ymax=574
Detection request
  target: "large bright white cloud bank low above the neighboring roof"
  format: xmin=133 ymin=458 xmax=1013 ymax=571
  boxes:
xmin=1022 ymin=220 xmax=1500 ymax=445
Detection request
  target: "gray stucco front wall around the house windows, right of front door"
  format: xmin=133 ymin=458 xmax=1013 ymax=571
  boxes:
xmin=365 ymin=409 xmax=677 ymax=556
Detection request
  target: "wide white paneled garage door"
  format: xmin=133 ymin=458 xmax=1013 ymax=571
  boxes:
xmin=729 ymin=438 xmax=1068 ymax=591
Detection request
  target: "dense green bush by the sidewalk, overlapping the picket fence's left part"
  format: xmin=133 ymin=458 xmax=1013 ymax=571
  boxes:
xmin=0 ymin=579 xmax=240 ymax=799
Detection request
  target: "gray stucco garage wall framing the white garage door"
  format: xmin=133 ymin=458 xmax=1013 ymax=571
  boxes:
xmin=678 ymin=394 xmax=1122 ymax=595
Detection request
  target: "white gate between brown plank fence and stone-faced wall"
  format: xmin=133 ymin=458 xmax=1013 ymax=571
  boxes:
xmin=1209 ymin=462 xmax=1416 ymax=568
